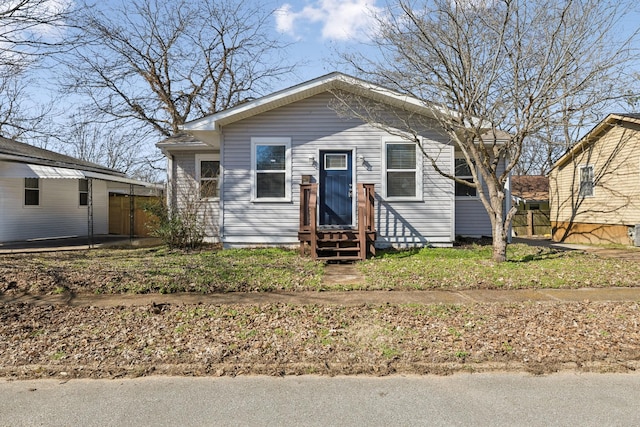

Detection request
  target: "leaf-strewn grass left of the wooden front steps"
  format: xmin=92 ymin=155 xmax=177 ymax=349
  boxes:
xmin=0 ymin=248 xmax=323 ymax=294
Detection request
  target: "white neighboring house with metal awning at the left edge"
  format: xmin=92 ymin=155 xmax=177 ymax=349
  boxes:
xmin=0 ymin=137 xmax=158 ymax=244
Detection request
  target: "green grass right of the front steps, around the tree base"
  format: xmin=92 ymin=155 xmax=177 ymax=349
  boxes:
xmin=359 ymin=244 xmax=640 ymax=290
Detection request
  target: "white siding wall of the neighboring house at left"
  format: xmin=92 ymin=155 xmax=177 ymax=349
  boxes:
xmin=0 ymin=178 xmax=109 ymax=242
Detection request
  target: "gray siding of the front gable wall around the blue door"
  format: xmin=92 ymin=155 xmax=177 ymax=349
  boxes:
xmin=222 ymin=94 xmax=454 ymax=246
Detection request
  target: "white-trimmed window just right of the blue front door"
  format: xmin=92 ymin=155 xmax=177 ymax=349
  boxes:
xmin=385 ymin=142 xmax=420 ymax=199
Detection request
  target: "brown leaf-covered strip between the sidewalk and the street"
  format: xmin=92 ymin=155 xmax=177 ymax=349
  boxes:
xmin=0 ymin=241 xmax=640 ymax=380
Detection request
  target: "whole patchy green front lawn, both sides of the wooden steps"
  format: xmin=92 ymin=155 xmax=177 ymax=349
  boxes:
xmin=5 ymin=244 xmax=640 ymax=296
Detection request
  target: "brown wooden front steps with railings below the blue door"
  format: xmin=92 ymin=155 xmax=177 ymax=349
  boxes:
xmin=298 ymin=183 xmax=376 ymax=261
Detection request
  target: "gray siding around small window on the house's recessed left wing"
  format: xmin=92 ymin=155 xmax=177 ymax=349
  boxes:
xmin=171 ymin=150 xmax=220 ymax=242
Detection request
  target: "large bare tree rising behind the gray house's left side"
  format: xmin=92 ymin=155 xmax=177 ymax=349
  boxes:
xmin=65 ymin=0 xmax=293 ymax=137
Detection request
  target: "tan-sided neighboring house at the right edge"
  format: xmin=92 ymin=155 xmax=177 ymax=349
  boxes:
xmin=549 ymin=114 xmax=640 ymax=245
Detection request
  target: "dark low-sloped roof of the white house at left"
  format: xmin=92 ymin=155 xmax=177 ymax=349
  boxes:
xmin=0 ymin=136 xmax=125 ymax=177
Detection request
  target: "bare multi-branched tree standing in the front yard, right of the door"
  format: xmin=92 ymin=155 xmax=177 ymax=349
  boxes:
xmin=338 ymin=0 xmax=634 ymax=262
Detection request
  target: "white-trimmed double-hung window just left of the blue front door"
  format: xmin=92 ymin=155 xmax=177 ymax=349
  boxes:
xmin=251 ymin=138 xmax=291 ymax=201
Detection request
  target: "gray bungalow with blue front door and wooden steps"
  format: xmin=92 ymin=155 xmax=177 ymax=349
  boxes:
xmin=157 ymin=73 xmax=508 ymax=259
